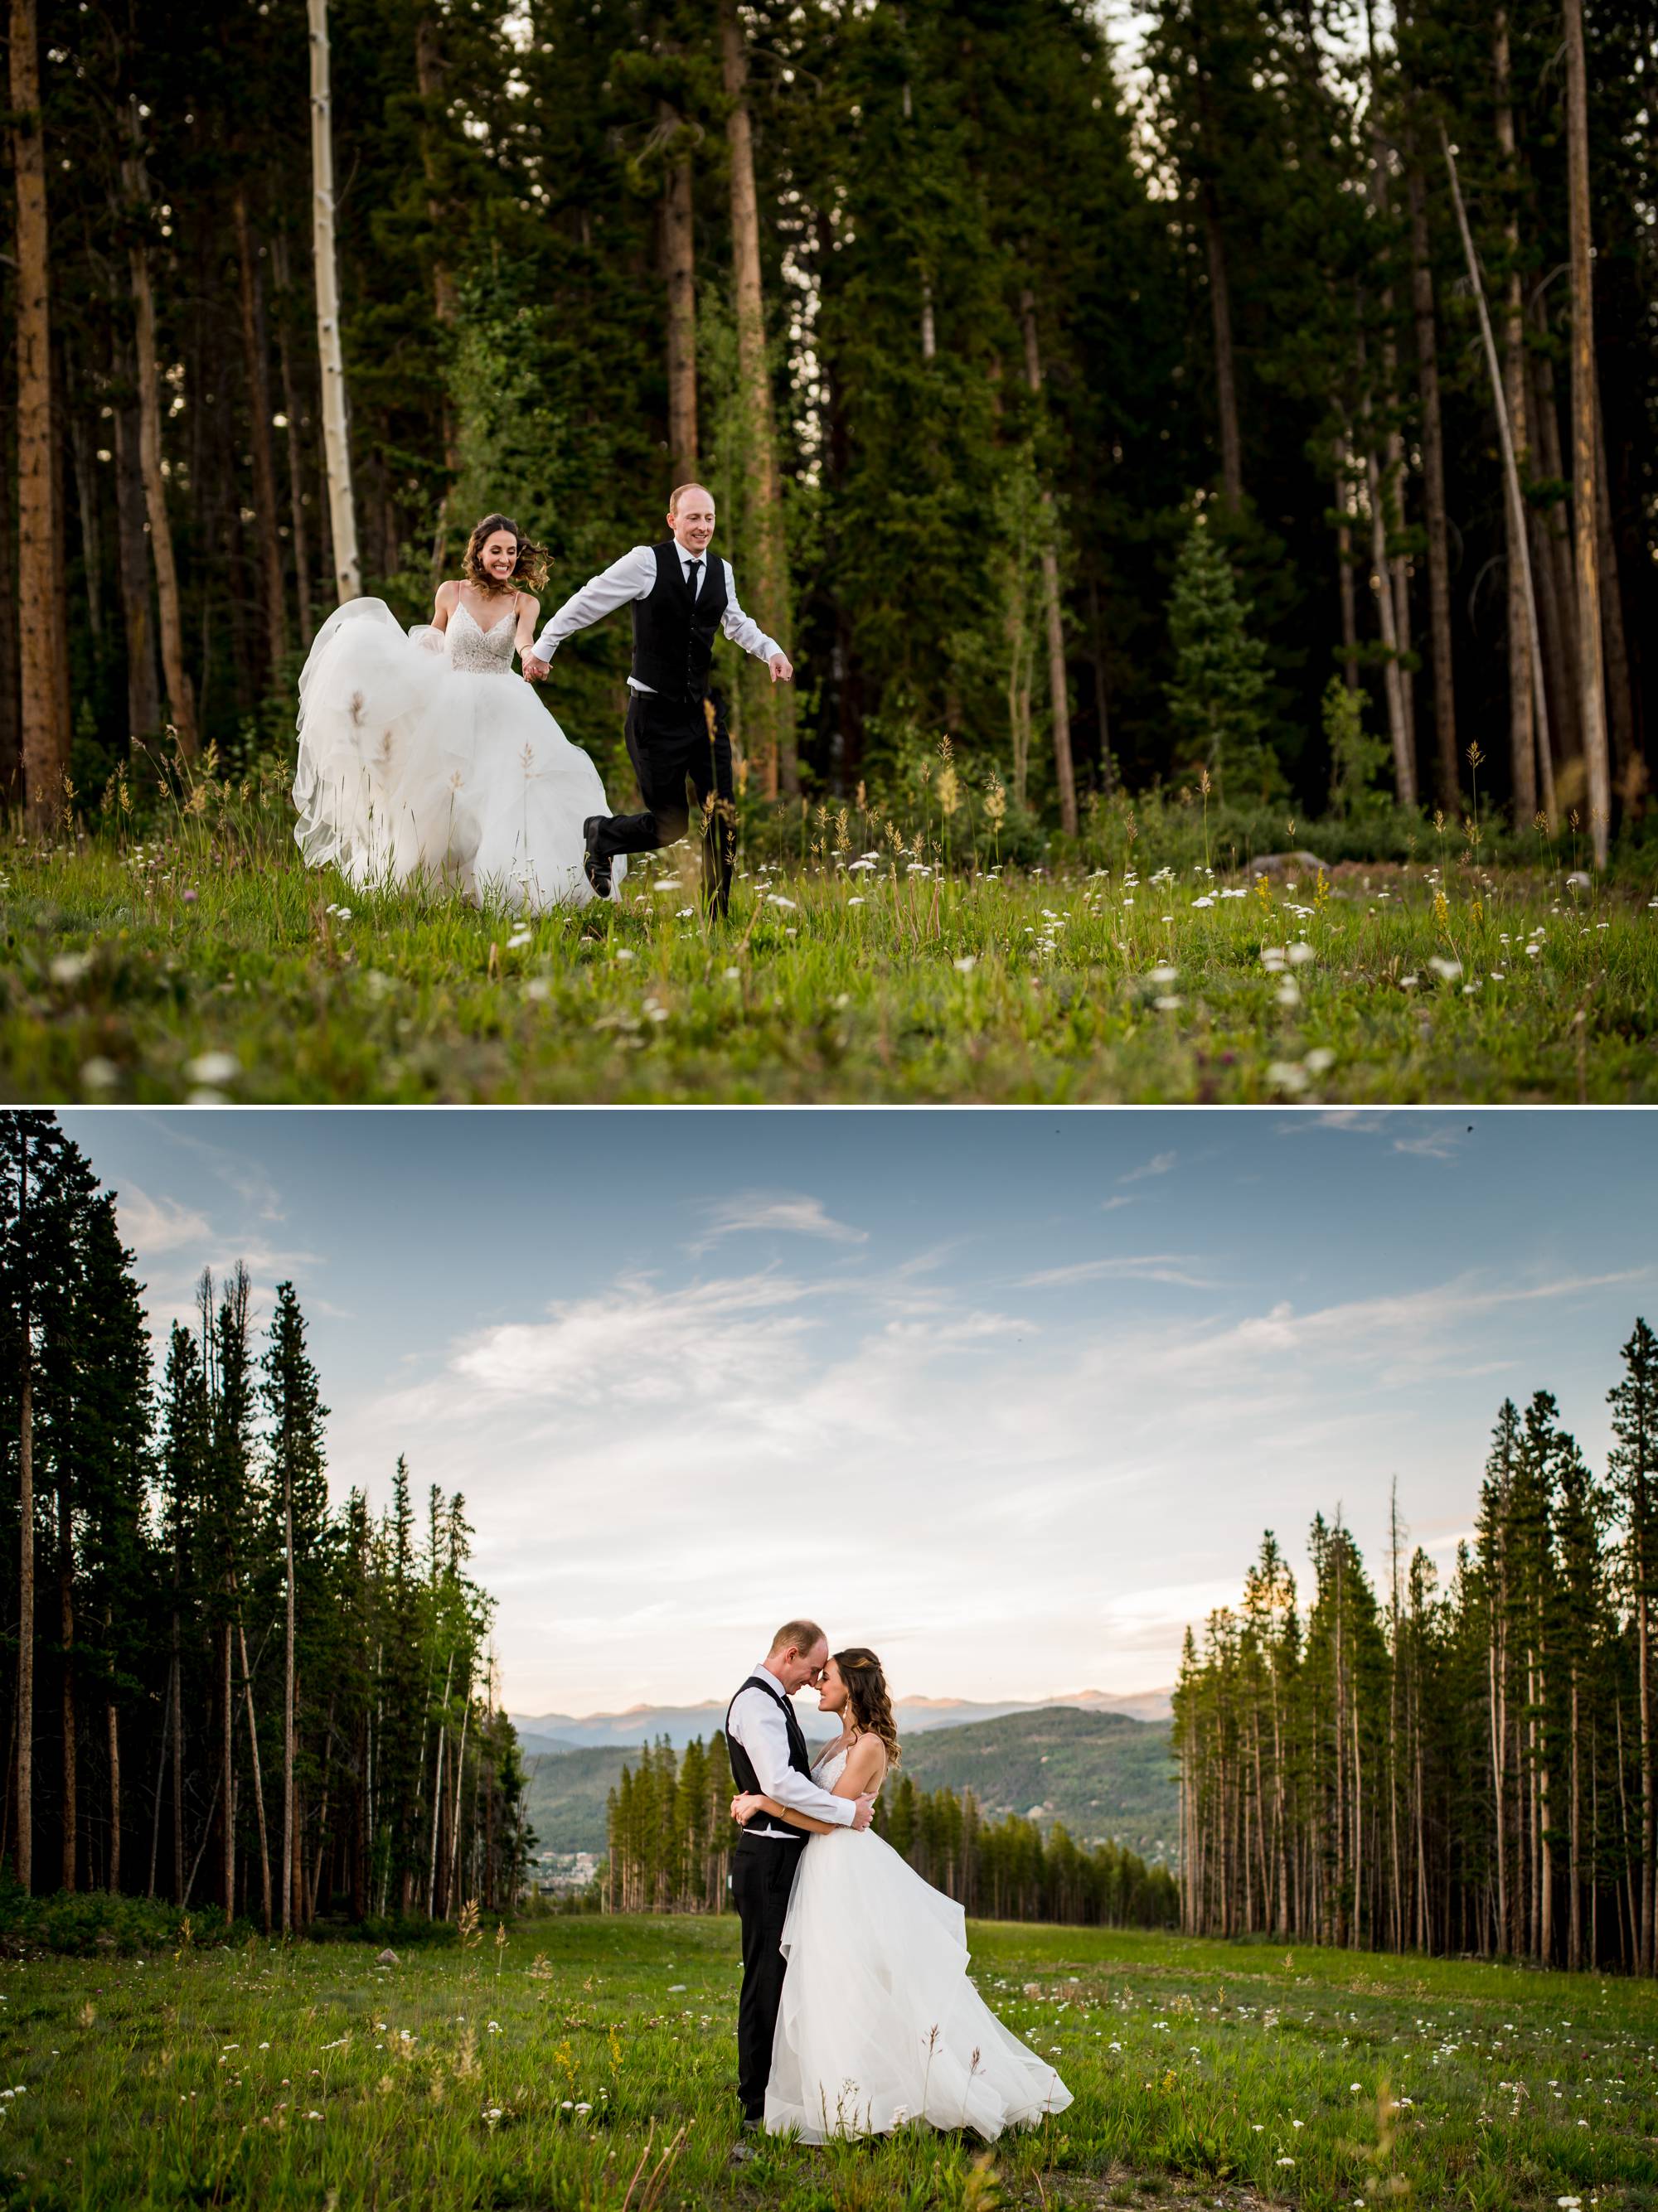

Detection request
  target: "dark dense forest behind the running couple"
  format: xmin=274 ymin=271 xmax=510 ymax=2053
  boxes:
xmin=0 ymin=0 xmax=1658 ymax=845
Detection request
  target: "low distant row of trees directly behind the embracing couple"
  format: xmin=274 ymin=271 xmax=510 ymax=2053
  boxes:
xmin=600 ymin=1730 xmax=1180 ymax=1927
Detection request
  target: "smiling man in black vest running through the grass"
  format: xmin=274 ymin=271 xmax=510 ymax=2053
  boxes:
xmin=525 ymin=485 xmax=795 ymax=913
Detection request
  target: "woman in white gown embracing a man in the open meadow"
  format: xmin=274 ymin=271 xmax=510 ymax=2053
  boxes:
xmin=730 ymin=1648 xmax=1071 ymax=2143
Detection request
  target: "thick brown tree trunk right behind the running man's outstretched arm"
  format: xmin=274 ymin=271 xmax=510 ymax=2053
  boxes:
xmin=720 ymin=0 xmax=799 ymax=799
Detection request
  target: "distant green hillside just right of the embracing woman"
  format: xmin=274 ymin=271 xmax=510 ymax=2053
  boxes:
xmin=903 ymin=1706 xmax=1180 ymax=1865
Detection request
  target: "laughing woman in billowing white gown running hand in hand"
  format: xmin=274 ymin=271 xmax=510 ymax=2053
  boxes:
xmin=294 ymin=515 xmax=620 ymax=913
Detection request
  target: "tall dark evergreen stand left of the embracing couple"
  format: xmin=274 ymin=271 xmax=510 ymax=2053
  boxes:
xmin=0 ymin=1113 xmax=529 ymax=1931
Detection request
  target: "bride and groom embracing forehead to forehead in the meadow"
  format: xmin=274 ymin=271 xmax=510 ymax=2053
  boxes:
xmin=726 ymin=1621 xmax=1071 ymax=2143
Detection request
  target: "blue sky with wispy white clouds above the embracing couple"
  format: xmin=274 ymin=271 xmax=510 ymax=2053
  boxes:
xmin=60 ymin=1108 xmax=1658 ymax=1714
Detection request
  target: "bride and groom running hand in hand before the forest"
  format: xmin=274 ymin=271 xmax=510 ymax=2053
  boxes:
xmin=294 ymin=485 xmax=795 ymax=913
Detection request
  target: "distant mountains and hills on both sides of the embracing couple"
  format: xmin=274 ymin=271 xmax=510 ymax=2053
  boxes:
xmin=516 ymin=1699 xmax=1180 ymax=1865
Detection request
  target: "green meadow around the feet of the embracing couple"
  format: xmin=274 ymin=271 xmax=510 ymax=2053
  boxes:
xmin=0 ymin=1918 xmax=1658 ymax=2212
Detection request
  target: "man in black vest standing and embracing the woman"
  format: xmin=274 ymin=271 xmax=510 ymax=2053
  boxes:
xmin=726 ymin=1621 xmax=875 ymax=2128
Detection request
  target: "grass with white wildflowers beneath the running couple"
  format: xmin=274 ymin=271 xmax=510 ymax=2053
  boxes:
xmin=0 ymin=785 xmax=1658 ymax=1101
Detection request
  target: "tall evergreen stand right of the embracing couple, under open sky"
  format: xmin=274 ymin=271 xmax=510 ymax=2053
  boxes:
xmin=1176 ymin=1320 xmax=1658 ymax=1973
